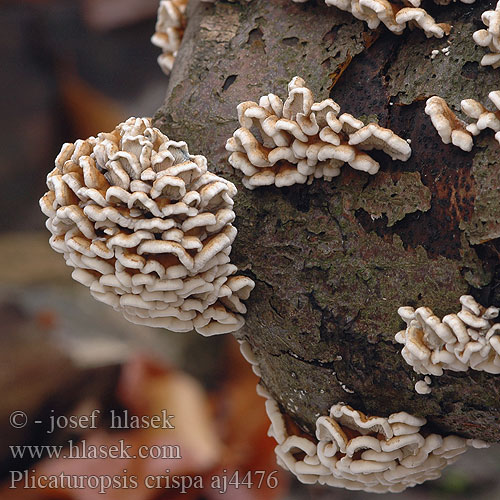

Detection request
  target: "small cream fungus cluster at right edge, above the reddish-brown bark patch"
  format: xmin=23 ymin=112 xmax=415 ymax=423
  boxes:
xmin=425 ymin=90 xmax=500 ymax=151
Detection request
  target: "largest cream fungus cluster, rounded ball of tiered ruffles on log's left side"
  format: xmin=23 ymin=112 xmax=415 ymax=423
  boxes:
xmin=40 ymin=118 xmax=254 ymax=335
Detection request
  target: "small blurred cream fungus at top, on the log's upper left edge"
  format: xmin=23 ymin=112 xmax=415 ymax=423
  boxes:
xmin=151 ymin=0 xmax=188 ymax=75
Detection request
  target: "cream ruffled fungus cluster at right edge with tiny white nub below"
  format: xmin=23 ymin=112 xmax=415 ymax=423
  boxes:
xmin=396 ymin=295 xmax=500 ymax=393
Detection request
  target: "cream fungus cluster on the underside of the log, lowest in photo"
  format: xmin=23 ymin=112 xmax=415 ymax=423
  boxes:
xmin=257 ymin=384 xmax=488 ymax=493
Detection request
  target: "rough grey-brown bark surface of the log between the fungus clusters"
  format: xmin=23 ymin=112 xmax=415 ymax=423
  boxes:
xmin=155 ymin=0 xmax=500 ymax=441
